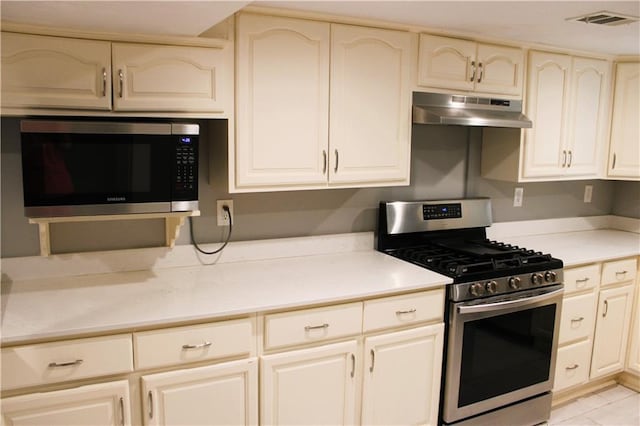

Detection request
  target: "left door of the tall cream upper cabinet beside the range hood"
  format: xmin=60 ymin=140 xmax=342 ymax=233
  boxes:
xmin=235 ymin=15 xmax=330 ymax=190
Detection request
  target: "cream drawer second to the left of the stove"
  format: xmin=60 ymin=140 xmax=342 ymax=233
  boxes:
xmin=264 ymin=303 xmax=362 ymax=350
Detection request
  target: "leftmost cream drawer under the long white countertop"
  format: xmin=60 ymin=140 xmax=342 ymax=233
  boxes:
xmin=2 ymin=334 xmax=133 ymax=390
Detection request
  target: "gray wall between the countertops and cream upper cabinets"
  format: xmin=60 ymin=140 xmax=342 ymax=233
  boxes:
xmin=0 ymin=118 xmax=640 ymax=257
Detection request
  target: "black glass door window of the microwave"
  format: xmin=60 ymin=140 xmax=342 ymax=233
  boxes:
xmin=22 ymin=133 xmax=173 ymax=206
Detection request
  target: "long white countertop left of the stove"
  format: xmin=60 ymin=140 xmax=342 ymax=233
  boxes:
xmin=2 ymin=250 xmax=451 ymax=345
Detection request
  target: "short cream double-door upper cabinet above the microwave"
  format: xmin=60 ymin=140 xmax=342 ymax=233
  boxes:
xmin=2 ymin=33 xmax=233 ymax=115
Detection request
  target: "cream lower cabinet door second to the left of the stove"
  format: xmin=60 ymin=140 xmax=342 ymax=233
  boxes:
xmin=260 ymin=340 xmax=358 ymax=425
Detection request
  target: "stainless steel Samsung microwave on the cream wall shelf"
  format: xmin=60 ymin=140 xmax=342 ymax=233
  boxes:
xmin=20 ymin=120 xmax=200 ymax=217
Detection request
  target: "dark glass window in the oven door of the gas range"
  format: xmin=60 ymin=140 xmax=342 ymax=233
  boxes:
xmin=458 ymin=304 xmax=556 ymax=407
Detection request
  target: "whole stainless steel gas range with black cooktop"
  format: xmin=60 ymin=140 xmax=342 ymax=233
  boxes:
xmin=376 ymin=198 xmax=563 ymax=426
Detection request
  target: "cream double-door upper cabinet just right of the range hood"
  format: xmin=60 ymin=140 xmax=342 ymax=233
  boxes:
xmin=481 ymin=51 xmax=610 ymax=182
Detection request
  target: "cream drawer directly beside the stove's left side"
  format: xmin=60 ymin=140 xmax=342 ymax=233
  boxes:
xmin=363 ymin=289 xmax=444 ymax=332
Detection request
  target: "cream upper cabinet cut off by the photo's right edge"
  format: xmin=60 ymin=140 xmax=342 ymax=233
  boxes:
xmin=607 ymin=62 xmax=640 ymax=180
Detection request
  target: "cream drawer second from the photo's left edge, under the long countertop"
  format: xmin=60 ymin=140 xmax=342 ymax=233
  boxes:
xmin=133 ymin=318 xmax=255 ymax=369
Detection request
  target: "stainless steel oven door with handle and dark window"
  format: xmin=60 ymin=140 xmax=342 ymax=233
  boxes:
xmin=443 ymin=284 xmax=563 ymax=423
